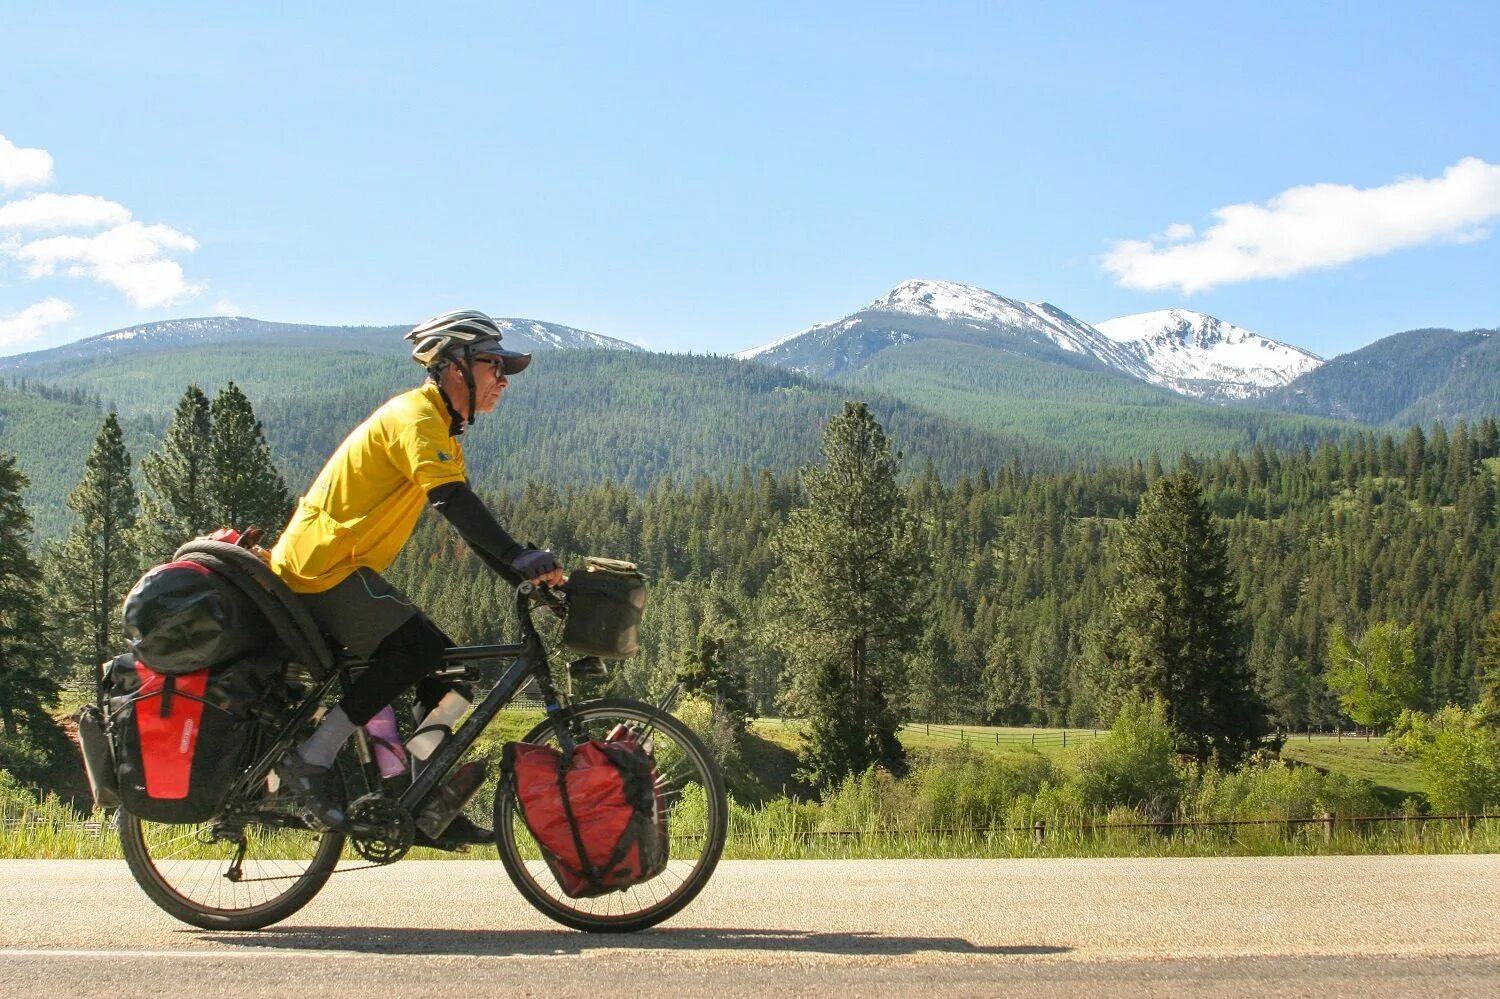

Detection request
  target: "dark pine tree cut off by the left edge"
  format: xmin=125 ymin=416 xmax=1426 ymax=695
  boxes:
xmin=0 ymin=455 xmax=57 ymax=735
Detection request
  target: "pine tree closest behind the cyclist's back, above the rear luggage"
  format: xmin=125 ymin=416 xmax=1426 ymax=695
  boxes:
xmin=212 ymin=381 xmax=291 ymax=542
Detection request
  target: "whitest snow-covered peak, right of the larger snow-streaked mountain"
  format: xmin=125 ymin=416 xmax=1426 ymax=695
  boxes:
xmin=1094 ymin=309 xmax=1323 ymax=399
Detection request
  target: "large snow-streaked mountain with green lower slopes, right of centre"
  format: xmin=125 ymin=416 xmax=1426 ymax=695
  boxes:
xmin=737 ymin=281 xmax=1344 ymax=459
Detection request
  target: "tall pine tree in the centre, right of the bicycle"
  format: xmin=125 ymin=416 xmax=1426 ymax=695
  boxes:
xmin=773 ymin=402 xmax=924 ymax=786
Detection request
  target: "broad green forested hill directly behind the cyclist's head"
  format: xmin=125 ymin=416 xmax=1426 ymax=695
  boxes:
xmin=0 ymin=345 xmax=1088 ymax=539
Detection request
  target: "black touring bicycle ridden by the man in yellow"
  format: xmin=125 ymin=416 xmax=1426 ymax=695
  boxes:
xmin=120 ymin=584 xmax=729 ymax=933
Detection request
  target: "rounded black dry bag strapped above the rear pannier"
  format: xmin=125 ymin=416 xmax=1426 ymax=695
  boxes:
xmin=125 ymin=561 xmax=270 ymax=675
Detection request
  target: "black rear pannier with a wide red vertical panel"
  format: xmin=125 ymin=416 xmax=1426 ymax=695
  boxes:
xmin=104 ymin=654 xmax=282 ymax=822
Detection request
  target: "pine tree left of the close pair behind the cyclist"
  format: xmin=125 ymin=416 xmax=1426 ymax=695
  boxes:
xmin=48 ymin=413 xmax=141 ymax=672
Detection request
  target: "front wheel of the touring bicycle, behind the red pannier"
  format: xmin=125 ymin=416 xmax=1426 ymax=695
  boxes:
xmin=495 ymin=699 xmax=729 ymax=933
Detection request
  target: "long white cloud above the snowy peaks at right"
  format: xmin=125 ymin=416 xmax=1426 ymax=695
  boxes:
xmin=1104 ymin=156 xmax=1500 ymax=294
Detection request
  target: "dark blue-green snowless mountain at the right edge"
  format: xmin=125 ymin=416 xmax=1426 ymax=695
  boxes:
xmin=1262 ymin=330 xmax=1500 ymax=426
